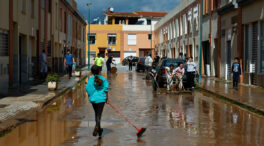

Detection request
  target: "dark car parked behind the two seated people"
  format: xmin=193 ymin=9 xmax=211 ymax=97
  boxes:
xmin=157 ymin=59 xmax=187 ymax=87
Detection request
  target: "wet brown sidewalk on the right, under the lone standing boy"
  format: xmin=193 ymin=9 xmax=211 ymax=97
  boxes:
xmin=200 ymin=78 xmax=264 ymax=114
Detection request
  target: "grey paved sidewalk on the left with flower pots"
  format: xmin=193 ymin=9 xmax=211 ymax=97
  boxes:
xmin=0 ymin=67 xmax=88 ymax=134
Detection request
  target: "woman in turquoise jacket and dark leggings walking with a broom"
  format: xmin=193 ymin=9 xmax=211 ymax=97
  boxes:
xmin=86 ymin=65 xmax=109 ymax=138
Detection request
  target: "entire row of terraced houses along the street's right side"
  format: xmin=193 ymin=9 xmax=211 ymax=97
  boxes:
xmin=154 ymin=0 xmax=264 ymax=86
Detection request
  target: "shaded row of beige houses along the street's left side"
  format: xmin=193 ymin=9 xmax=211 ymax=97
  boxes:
xmin=0 ymin=0 xmax=86 ymax=92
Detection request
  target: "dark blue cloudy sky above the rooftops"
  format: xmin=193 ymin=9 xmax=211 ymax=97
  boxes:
xmin=76 ymin=0 xmax=181 ymax=20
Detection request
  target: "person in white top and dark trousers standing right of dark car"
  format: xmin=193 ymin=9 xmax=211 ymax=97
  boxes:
xmin=187 ymin=56 xmax=198 ymax=89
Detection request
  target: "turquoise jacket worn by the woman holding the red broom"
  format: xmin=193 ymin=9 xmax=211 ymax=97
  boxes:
xmin=86 ymin=75 xmax=109 ymax=103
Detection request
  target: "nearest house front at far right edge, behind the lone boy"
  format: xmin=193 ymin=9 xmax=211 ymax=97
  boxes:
xmin=237 ymin=0 xmax=264 ymax=87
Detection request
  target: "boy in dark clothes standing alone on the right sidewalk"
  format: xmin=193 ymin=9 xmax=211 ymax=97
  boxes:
xmin=232 ymin=57 xmax=241 ymax=90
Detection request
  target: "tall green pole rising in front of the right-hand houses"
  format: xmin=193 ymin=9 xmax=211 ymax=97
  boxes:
xmin=199 ymin=0 xmax=203 ymax=84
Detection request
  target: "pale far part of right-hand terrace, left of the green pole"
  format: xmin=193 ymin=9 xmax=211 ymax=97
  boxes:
xmin=154 ymin=0 xmax=200 ymax=67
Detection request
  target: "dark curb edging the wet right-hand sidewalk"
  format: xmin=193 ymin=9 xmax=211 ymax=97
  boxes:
xmin=196 ymin=86 xmax=264 ymax=116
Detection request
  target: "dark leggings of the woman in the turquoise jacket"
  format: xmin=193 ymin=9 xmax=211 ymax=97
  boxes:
xmin=92 ymin=102 xmax=105 ymax=129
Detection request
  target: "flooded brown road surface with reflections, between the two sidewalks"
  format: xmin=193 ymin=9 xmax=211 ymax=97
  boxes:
xmin=0 ymin=73 xmax=264 ymax=146
